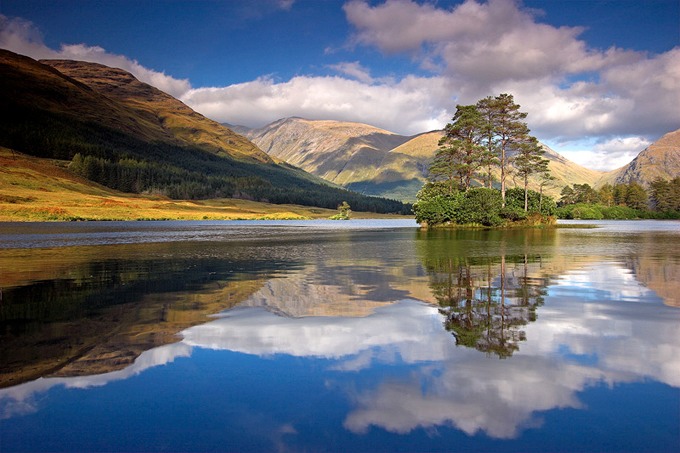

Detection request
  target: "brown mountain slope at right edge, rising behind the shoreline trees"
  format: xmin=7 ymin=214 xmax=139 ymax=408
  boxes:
xmin=598 ymin=129 xmax=680 ymax=185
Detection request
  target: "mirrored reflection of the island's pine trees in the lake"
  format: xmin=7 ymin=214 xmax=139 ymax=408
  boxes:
xmin=419 ymin=231 xmax=549 ymax=359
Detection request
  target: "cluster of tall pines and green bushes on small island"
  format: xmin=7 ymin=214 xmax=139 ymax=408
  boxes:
xmin=413 ymin=94 xmax=556 ymax=227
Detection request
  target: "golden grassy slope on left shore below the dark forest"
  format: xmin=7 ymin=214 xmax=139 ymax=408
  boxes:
xmin=0 ymin=147 xmax=410 ymax=221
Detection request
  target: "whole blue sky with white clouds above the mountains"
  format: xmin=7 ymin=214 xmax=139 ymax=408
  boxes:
xmin=0 ymin=0 xmax=680 ymax=169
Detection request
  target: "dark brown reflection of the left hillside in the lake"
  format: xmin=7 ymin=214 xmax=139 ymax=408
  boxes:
xmin=0 ymin=238 xmax=298 ymax=387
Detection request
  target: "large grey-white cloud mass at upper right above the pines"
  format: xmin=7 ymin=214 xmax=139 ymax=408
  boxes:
xmin=345 ymin=0 xmax=680 ymax=169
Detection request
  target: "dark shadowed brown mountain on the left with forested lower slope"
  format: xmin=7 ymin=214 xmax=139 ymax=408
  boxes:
xmin=0 ymin=50 xmax=404 ymax=212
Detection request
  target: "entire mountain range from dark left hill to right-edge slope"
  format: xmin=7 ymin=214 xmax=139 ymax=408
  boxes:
xmin=0 ymin=49 xmax=680 ymax=212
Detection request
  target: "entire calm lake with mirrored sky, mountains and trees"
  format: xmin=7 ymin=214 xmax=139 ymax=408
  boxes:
xmin=0 ymin=220 xmax=680 ymax=452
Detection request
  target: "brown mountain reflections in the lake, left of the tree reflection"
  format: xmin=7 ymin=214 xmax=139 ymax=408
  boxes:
xmin=0 ymin=224 xmax=420 ymax=387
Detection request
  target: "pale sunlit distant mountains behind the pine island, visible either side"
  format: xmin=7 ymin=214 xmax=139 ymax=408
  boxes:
xmin=244 ymin=118 xmax=603 ymax=202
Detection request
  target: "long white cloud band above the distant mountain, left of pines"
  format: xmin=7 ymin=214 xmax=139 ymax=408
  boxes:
xmin=181 ymin=76 xmax=451 ymax=134
